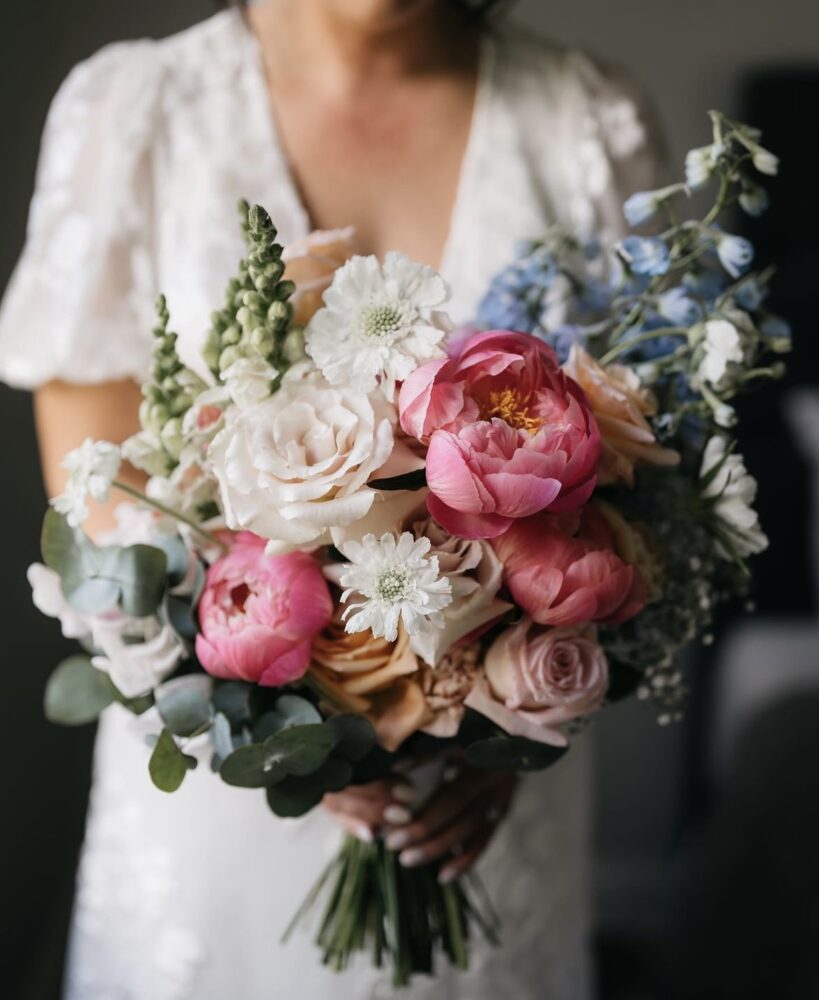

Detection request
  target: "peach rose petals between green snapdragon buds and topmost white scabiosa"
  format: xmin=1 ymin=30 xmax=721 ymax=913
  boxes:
xmin=282 ymin=226 xmax=355 ymax=326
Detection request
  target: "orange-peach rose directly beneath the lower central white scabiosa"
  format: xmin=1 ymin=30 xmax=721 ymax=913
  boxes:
xmin=310 ymin=615 xmax=430 ymax=750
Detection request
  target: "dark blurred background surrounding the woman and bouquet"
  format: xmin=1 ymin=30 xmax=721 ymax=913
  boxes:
xmin=0 ymin=0 xmax=819 ymax=1000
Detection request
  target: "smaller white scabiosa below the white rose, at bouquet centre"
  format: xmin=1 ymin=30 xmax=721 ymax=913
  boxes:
xmin=339 ymin=531 xmax=452 ymax=642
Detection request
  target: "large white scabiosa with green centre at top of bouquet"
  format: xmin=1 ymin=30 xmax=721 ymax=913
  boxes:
xmin=305 ymin=253 xmax=449 ymax=400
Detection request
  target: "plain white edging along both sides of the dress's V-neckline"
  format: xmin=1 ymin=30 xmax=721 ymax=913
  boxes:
xmin=232 ymin=11 xmax=497 ymax=276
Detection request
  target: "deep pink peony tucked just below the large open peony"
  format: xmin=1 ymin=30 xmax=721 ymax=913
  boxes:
xmin=492 ymin=506 xmax=647 ymax=625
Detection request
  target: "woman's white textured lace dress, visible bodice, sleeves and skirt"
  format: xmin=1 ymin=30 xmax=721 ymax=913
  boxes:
xmin=0 ymin=12 xmax=668 ymax=1000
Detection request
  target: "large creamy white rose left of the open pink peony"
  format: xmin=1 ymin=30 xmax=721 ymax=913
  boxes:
xmin=209 ymin=376 xmax=395 ymax=552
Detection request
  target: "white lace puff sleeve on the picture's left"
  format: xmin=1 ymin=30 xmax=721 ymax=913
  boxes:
xmin=0 ymin=42 xmax=160 ymax=388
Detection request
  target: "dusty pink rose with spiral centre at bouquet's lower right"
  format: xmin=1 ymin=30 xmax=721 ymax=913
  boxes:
xmin=467 ymin=618 xmax=609 ymax=746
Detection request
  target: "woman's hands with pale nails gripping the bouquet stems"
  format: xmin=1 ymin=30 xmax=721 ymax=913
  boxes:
xmin=324 ymin=762 xmax=517 ymax=883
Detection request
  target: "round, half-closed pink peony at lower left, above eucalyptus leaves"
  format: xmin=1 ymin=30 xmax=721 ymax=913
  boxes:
xmin=196 ymin=531 xmax=333 ymax=687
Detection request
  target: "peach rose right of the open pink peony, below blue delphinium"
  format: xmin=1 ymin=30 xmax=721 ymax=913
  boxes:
xmin=563 ymin=344 xmax=680 ymax=486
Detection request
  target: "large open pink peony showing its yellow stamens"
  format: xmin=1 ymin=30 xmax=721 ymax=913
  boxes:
xmin=399 ymin=331 xmax=600 ymax=538
